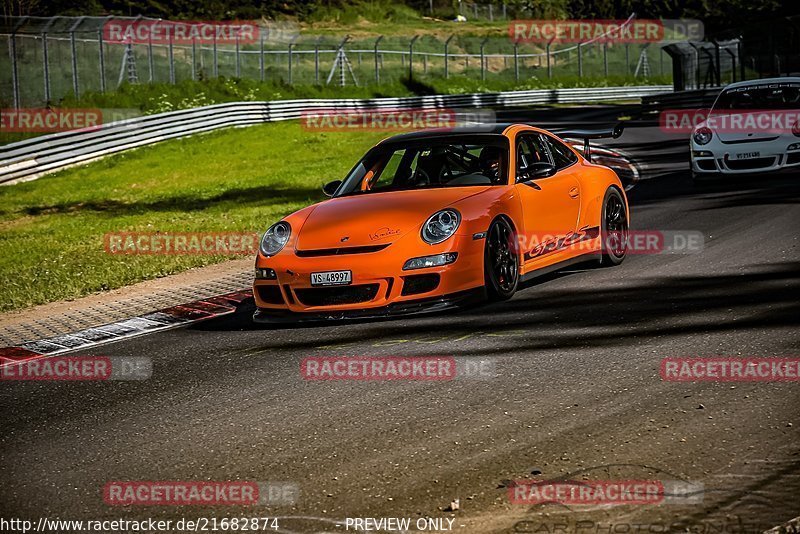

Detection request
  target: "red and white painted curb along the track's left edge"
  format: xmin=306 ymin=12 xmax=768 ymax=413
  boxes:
xmin=0 ymin=289 xmax=252 ymax=366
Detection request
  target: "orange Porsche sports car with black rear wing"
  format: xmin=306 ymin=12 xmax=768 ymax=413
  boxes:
xmin=253 ymin=124 xmax=629 ymax=322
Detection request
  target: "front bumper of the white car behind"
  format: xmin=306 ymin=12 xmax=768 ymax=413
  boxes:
xmin=690 ymin=142 xmax=800 ymax=174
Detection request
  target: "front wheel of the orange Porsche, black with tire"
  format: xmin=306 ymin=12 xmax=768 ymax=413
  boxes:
xmin=483 ymin=217 xmax=519 ymax=301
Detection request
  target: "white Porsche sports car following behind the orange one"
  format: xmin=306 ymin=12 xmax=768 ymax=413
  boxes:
xmin=689 ymin=77 xmax=800 ymax=180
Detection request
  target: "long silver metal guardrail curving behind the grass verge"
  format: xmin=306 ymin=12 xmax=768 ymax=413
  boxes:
xmin=0 ymin=85 xmax=672 ymax=183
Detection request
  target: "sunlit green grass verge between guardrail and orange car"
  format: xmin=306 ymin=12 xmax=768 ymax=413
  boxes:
xmin=0 ymin=122 xmax=386 ymax=311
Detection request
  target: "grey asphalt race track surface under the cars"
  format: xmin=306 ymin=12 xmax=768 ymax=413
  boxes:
xmin=0 ymin=117 xmax=800 ymax=533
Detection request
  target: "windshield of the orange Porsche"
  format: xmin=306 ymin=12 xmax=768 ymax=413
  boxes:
xmin=336 ymin=135 xmax=509 ymax=196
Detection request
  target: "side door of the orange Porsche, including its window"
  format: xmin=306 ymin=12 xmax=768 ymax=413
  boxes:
xmin=515 ymin=132 xmax=581 ymax=270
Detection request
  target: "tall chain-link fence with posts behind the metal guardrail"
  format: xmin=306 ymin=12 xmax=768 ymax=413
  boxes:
xmin=0 ymin=17 xmax=684 ymax=107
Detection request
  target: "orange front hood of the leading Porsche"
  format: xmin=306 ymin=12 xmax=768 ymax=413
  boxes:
xmin=295 ymin=186 xmax=490 ymax=250
